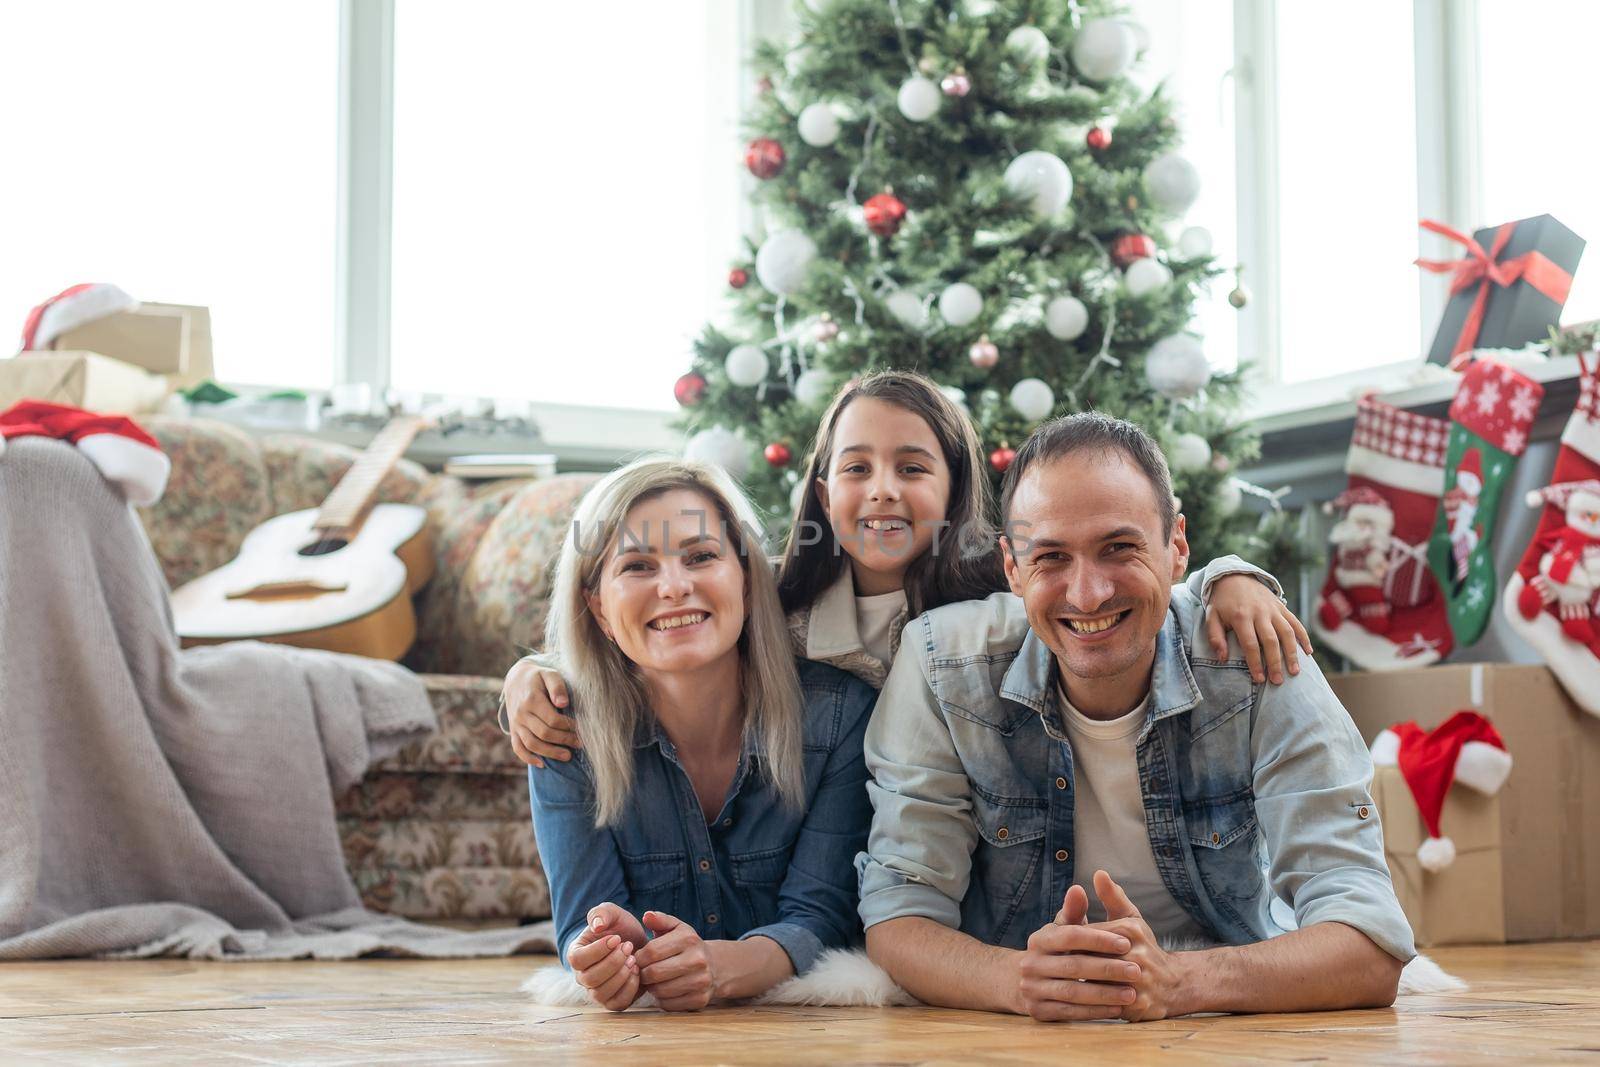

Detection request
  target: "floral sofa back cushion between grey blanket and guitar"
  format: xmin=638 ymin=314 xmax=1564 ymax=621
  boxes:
xmin=139 ymin=416 xmax=274 ymax=587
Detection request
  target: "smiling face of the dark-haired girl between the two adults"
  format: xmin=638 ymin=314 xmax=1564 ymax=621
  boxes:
xmin=816 ymin=397 xmax=950 ymax=595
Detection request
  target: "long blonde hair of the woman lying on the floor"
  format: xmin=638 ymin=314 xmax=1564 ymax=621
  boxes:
xmin=544 ymin=458 xmax=805 ymax=825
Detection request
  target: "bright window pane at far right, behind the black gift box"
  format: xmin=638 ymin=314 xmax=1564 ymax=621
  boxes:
xmin=1477 ymin=0 xmax=1600 ymax=323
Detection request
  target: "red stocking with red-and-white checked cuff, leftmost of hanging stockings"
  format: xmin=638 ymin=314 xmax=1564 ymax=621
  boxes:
xmin=1312 ymin=397 xmax=1454 ymax=670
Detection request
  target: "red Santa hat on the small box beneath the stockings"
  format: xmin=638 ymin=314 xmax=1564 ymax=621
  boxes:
xmin=1373 ymin=712 xmax=1510 ymax=870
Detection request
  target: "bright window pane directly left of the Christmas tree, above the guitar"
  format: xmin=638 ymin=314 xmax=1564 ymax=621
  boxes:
xmin=390 ymin=0 xmax=744 ymax=408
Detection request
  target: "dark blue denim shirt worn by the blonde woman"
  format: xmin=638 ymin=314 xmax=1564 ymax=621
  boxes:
xmin=528 ymin=661 xmax=875 ymax=974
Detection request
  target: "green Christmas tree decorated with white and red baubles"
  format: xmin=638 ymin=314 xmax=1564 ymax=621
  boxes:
xmin=675 ymin=0 xmax=1294 ymax=566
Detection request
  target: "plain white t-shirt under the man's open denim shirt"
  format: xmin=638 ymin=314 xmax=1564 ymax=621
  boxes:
xmin=1056 ymin=686 xmax=1210 ymax=939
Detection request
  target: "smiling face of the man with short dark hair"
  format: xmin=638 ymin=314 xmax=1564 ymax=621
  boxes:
xmin=1002 ymin=451 xmax=1189 ymax=686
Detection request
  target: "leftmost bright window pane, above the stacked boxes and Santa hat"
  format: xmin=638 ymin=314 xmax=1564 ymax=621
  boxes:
xmin=0 ymin=0 xmax=339 ymax=387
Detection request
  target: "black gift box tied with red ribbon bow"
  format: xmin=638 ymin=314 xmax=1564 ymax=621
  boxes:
xmin=1427 ymin=214 xmax=1584 ymax=365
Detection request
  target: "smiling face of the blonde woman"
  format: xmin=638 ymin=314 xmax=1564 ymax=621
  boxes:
xmin=584 ymin=490 xmax=746 ymax=672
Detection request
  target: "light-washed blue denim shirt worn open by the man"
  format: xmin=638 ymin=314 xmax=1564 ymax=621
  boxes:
xmin=856 ymin=589 xmax=1416 ymax=960
